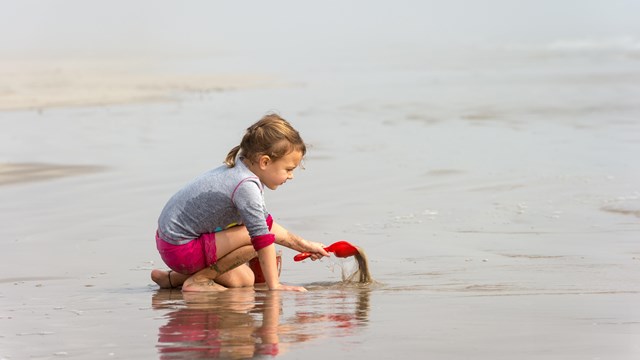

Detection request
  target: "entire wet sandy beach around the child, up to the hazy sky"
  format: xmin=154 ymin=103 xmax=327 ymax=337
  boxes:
xmin=0 ymin=1 xmax=640 ymax=360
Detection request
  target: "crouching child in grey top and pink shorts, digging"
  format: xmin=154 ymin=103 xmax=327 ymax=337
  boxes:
xmin=151 ymin=114 xmax=329 ymax=291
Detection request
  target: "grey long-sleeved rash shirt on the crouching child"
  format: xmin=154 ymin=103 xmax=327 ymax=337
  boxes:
xmin=158 ymin=158 xmax=269 ymax=245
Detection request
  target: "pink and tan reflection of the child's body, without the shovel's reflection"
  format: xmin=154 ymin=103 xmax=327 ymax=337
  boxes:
xmin=151 ymin=289 xmax=284 ymax=359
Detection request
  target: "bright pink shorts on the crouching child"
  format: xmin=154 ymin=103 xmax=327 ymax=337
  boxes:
xmin=156 ymin=232 xmax=218 ymax=275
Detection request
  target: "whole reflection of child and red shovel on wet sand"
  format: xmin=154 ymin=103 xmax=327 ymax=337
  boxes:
xmin=152 ymin=287 xmax=370 ymax=359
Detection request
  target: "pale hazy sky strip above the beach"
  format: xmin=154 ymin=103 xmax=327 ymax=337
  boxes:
xmin=0 ymin=0 xmax=640 ymax=57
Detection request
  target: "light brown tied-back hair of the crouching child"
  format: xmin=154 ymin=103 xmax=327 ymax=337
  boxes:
xmin=224 ymin=114 xmax=307 ymax=168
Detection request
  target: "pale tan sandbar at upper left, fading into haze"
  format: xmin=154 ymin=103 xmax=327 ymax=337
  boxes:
xmin=0 ymin=58 xmax=280 ymax=111
